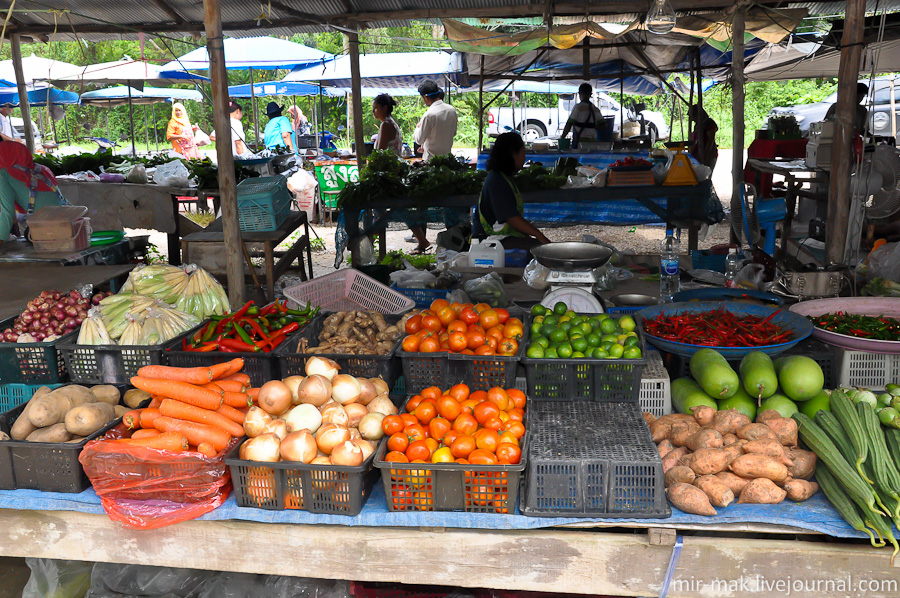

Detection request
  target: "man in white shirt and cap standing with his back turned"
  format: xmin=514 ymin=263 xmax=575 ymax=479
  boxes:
xmin=406 ymin=79 xmax=458 ymax=253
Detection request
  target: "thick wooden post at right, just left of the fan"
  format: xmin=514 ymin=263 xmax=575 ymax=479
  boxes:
xmin=825 ymin=0 xmax=866 ymax=264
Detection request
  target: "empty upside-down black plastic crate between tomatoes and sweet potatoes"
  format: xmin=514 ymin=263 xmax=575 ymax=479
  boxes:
xmin=522 ymin=401 xmax=671 ymax=518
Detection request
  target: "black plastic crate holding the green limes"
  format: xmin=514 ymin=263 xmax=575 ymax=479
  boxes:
xmin=521 ymin=314 xmax=647 ymax=403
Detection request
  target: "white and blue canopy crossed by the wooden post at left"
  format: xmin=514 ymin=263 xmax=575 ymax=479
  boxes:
xmin=163 ymin=37 xmax=335 ymax=71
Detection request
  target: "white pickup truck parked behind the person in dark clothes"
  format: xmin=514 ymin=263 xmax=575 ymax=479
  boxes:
xmin=487 ymin=91 xmax=669 ymax=143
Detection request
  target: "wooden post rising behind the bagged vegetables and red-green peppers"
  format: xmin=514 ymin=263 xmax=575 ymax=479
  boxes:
xmin=203 ymin=0 xmax=244 ymax=309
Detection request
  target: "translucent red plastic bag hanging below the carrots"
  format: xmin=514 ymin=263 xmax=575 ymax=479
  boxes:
xmin=78 ymin=425 xmax=237 ymax=529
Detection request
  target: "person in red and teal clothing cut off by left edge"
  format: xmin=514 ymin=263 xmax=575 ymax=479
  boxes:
xmin=0 ymin=138 xmax=63 ymax=243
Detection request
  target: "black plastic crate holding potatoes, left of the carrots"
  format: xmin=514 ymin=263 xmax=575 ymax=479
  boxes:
xmin=0 ymin=394 xmax=122 ymax=493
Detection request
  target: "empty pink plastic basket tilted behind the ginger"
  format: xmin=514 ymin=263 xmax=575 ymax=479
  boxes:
xmin=284 ymin=268 xmax=416 ymax=314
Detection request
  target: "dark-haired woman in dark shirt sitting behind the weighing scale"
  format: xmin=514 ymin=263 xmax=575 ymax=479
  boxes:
xmin=472 ymin=133 xmax=550 ymax=249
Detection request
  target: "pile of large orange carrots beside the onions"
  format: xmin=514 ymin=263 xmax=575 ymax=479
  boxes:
xmin=108 ymin=358 xmax=259 ymax=457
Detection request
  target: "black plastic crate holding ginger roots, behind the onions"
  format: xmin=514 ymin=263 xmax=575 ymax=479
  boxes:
xmin=275 ymin=312 xmax=403 ymax=388
